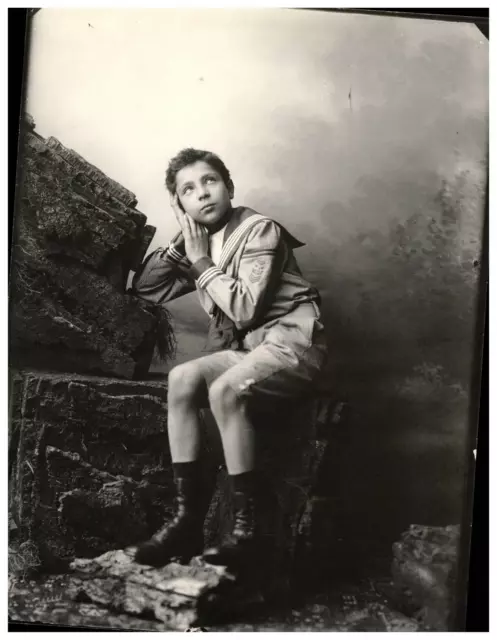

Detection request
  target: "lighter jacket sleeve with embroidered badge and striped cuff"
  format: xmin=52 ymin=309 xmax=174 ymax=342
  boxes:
xmin=191 ymin=220 xmax=284 ymax=329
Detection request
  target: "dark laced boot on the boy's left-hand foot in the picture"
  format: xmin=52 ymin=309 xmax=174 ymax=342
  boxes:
xmin=134 ymin=478 xmax=206 ymax=567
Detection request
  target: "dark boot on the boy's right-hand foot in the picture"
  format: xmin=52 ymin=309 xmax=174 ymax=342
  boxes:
xmin=202 ymin=491 xmax=257 ymax=569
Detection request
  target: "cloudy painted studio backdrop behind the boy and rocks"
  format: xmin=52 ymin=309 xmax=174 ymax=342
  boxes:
xmin=26 ymin=9 xmax=488 ymax=570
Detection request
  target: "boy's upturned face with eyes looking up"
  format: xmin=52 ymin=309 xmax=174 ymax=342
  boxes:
xmin=176 ymin=160 xmax=233 ymax=226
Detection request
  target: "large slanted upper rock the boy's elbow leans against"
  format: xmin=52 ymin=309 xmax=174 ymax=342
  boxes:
xmin=10 ymin=115 xmax=173 ymax=378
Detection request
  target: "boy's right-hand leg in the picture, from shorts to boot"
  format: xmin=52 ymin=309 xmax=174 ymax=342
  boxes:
xmin=204 ymin=343 xmax=322 ymax=568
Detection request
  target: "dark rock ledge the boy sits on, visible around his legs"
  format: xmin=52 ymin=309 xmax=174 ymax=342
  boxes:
xmin=9 ymin=364 xmax=338 ymax=592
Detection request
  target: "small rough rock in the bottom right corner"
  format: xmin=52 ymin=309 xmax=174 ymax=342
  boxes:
xmin=392 ymin=525 xmax=460 ymax=631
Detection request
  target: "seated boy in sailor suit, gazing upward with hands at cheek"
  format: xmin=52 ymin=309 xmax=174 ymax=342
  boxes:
xmin=132 ymin=149 xmax=327 ymax=566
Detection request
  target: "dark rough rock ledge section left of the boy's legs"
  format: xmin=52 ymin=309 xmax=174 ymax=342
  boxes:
xmin=9 ymin=372 xmax=172 ymax=569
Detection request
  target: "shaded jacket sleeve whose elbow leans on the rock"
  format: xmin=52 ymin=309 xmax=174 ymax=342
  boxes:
xmin=129 ymin=234 xmax=196 ymax=304
